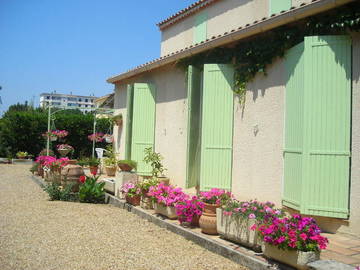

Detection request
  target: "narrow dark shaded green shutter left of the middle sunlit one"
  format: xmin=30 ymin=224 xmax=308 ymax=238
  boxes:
xmin=186 ymin=66 xmax=201 ymax=188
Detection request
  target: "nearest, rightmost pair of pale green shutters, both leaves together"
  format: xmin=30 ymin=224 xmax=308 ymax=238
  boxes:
xmin=283 ymin=36 xmax=351 ymax=218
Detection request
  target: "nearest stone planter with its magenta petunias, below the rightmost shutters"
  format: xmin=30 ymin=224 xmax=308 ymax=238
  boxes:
xmin=257 ymin=215 xmax=328 ymax=269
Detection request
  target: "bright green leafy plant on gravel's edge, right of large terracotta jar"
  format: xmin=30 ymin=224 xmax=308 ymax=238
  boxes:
xmin=79 ymin=176 xmax=105 ymax=203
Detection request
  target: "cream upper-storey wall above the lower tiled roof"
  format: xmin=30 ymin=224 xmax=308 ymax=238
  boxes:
xmin=161 ymin=0 xmax=311 ymax=56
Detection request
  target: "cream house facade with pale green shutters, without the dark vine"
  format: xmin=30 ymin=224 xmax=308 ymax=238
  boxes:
xmin=108 ymin=0 xmax=360 ymax=235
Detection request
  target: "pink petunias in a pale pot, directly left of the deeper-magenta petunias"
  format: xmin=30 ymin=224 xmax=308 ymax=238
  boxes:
xmin=148 ymin=183 xmax=187 ymax=219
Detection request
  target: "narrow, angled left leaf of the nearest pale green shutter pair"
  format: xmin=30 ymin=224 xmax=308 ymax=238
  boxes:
xmin=283 ymin=42 xmax=304 ymax=210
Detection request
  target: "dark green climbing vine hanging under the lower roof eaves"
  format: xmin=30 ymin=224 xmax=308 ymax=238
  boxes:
xmin=177 ymin=3 xmax=360 ymax=104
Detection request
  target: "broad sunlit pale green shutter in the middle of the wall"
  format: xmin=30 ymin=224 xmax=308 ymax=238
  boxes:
xmin=200 ymin=64 xmax=234 ymax=190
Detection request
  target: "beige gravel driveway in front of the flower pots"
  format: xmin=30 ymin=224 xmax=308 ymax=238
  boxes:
xmin=0 ymin=165 xmax=246 ymax=270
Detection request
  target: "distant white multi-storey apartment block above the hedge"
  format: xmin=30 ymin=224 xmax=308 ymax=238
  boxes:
xmin=40 ymin=93 xmax=97 ymax=111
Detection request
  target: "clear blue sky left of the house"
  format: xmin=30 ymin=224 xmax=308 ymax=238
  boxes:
xmin=0 ymin=0 xmax=194 ymax=114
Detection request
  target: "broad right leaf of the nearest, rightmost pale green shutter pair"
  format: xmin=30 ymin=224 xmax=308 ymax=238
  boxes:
xmin=301 ymin=36 xmax=351 ymax=218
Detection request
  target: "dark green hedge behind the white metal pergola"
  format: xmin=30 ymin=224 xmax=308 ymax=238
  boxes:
xmin=0 ymin=109 xmax=109 ymax=158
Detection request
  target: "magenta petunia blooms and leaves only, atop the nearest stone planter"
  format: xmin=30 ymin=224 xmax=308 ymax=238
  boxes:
xmin=257 ymin=215 xmax=328 ymax=252
